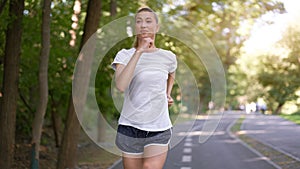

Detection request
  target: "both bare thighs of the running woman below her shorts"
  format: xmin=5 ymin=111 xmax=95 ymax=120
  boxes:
xmin=123 ymin=145 xmax=168 ymax=169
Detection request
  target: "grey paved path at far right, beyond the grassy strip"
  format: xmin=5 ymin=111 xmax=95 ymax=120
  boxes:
xmin=241 ymin=114 xmax=300 ymax=161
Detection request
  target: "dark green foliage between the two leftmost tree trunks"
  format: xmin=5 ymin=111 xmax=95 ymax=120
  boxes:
xmin=17 ymin=1 xmax=42 ymax=134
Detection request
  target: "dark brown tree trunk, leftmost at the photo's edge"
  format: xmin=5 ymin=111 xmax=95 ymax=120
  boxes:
xmin=0 ymin=0 xmax=24 ymax=169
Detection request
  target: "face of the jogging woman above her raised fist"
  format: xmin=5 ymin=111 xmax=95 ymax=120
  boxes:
xmin=135 ymin=11 xmax=159 ymax=38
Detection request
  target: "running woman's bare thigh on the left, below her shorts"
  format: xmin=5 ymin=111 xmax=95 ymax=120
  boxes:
xmin=122 ymin=153 xmax=143 ymax=169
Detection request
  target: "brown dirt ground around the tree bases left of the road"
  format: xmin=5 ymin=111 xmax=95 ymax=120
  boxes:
xmin=12 ymin=127 xmax=120 ymax=169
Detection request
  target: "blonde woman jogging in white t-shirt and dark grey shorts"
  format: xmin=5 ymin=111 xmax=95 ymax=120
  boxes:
xmin=112 ymin=8 xmax=177 ymax=169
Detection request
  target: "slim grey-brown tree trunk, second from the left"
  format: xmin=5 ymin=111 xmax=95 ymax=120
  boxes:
xmin=31 ymin=0 xmax=51 ymax=169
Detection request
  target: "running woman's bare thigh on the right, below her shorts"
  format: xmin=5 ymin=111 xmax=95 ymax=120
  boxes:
xmin=143 ymin=145 xmax=168 ymax=169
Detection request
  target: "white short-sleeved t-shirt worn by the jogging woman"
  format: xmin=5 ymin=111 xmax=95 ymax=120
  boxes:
xmin=112 ymin=48 xmax=177 ymax=131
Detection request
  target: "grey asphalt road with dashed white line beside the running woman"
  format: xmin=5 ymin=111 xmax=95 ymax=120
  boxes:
xmin=111 ymin=113 xmax=276 ymax=169
